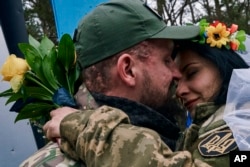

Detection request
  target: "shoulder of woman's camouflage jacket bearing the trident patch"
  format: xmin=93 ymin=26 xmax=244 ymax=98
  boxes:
xmin=177 ymin=103 xmax=237 ymax=167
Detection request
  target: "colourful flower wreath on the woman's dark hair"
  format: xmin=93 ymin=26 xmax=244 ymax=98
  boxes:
xmin=195 ymin=19 xmax=246 ymax=51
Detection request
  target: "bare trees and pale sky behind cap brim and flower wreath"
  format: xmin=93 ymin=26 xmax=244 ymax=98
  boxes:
xmin=153 ymin=0 xmax=250 ymax=34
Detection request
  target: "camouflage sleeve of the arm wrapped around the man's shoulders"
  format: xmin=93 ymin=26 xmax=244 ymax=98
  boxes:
xmin=61 ymin=106 xmax=209 ymax=167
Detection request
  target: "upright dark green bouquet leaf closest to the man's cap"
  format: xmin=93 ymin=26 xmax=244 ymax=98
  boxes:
xmin=58 ymin=34 xmax=75 ymax=72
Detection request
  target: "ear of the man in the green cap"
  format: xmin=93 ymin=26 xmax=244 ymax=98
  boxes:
xmin=116 ymin=54 xmax=136 ymax=86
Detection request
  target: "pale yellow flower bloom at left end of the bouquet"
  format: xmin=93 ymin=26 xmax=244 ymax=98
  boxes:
xmin=0 ymin=54 xmax=29 ymax=92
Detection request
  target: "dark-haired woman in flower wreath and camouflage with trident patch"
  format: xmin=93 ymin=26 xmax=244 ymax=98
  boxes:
xmin=175 ymin=20 xmax=249 ymax=167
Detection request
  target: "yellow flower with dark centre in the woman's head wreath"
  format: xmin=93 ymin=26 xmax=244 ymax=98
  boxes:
xmin=206 ymin=23 xmax=230 ymax=48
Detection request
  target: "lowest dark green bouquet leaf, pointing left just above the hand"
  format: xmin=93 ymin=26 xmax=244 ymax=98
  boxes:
xmin=15 ymin=102 xmax=55 ymax=123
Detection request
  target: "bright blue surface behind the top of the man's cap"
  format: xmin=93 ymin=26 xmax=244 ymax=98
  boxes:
xmin=51 ymin=0 xmax=107 ymax=39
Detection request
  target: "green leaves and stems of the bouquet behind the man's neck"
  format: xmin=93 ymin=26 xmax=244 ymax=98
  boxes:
xmin=0 ymin=34 xmax=80 ymax=122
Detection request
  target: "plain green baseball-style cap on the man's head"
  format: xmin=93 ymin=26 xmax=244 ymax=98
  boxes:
xmin=74 ymin=0 xmax=200 ymax=68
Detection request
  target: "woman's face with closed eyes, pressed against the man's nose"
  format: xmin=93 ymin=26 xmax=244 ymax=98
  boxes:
xmin=175 ymin=50 xmax=222 ymax=117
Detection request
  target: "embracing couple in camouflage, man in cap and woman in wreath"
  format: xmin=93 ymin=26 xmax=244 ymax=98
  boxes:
xmin=21 ymin=0 xmax=249 ymax=167
